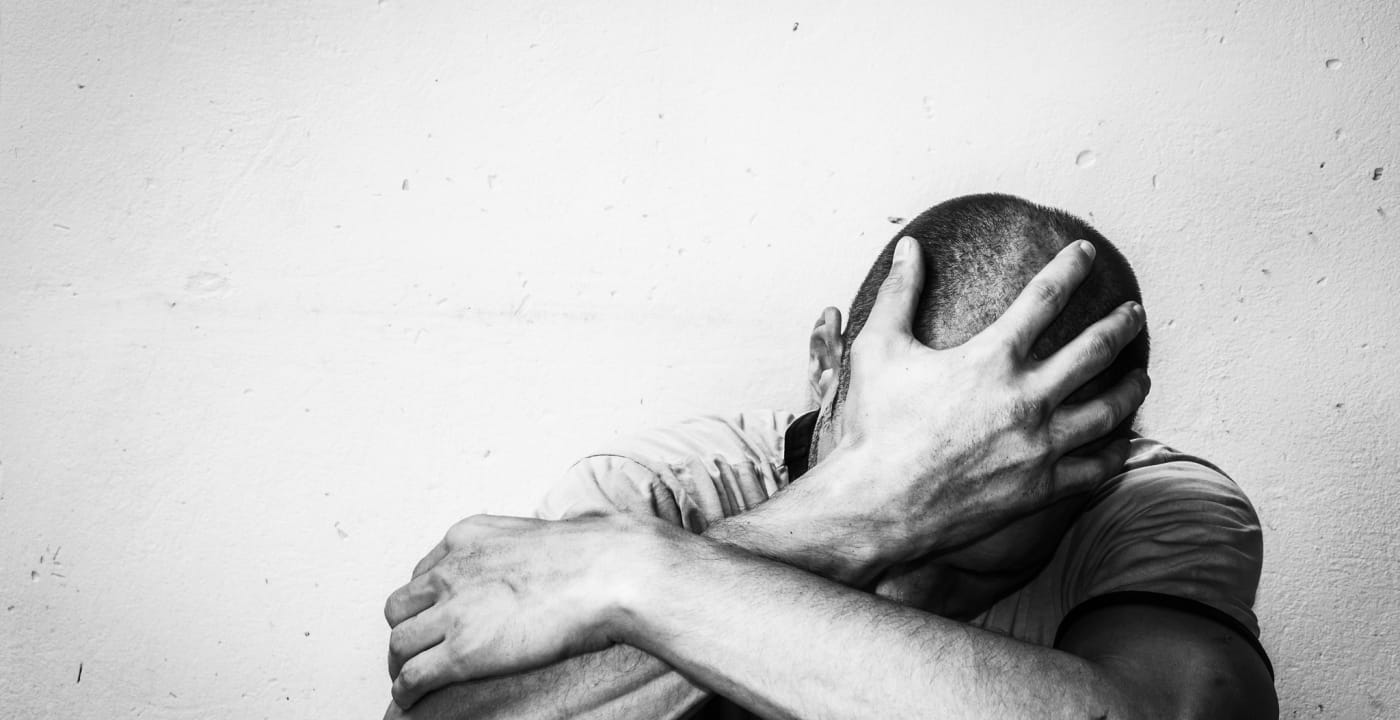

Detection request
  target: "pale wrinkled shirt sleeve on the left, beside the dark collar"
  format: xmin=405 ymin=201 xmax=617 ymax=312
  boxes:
xmin=535 ymin=410 xmax=794 ymax=532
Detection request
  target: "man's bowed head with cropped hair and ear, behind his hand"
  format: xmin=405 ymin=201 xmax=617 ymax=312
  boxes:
xmin=811 ymin=195 xmax=1148 ymax=607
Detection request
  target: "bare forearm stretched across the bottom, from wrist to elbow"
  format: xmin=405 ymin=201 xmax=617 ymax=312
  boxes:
xmin=619 ymin=521 xmax=1140 ymax=719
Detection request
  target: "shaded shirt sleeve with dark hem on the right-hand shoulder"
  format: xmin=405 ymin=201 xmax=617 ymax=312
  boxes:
xmin=1063 ymin=445 xmax=1264 ymax=639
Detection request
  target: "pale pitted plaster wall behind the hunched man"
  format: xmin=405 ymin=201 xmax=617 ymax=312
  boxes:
xmin=0 ymin=0 xmax=1400 ymax=719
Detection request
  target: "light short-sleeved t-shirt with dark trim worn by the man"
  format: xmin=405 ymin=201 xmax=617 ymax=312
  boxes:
xmin=536 ymin=410 xmax=1268 ymax=708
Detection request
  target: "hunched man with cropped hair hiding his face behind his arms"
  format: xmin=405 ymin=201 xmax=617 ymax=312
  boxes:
xmin=385 ymin=196 xmax=1277 ymax=719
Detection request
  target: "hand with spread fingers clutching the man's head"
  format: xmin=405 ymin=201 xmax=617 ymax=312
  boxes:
xmin=827 ymin=238 xmax=1149 ymax=570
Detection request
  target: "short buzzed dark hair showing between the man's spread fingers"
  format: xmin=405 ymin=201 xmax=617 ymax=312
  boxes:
xmin=837 ymin=193 xmax=1149 ymax=436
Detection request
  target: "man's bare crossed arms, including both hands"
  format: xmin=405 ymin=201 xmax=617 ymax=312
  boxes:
xmin=386 ymin=240 xmax=1277 ymax=717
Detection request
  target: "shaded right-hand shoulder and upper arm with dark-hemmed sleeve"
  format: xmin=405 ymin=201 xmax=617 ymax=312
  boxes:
xmin=1053 ymin=438 xmax=1278 ymax=705
